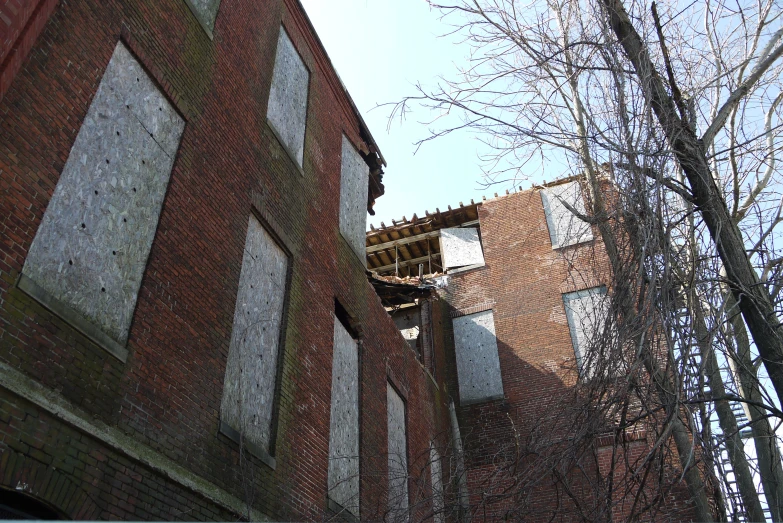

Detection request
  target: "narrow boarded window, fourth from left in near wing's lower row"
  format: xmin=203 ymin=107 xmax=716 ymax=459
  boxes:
xmin=386 ymin=383 xmax=408 ymax=521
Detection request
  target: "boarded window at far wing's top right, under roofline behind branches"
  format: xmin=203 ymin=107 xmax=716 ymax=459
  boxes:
xmin=541 ymin=182 xmax=593 ymax=249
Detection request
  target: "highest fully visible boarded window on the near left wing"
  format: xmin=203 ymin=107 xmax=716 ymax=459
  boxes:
xmin=266 ymin=27 xmax=310 ymax=167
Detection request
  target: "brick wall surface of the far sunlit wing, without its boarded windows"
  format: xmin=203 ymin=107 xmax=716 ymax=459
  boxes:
xmin=440 ymin=189 xmax=704 ymax=522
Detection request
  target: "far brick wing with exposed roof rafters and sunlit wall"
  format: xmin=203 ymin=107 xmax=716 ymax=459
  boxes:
xmin=367 ymin=179 xmax=704 ymax=522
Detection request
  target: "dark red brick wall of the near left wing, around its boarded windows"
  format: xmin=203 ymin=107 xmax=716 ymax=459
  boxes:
xmin=0 ymin=0 xmax=448 ymax=519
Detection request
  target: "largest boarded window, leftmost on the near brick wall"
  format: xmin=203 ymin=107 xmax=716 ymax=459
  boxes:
xmin=22 ymin=43 xmax=185 ymax=344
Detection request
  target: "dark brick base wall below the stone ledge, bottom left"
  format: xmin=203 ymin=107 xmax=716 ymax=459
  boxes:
xmin=0 ymin=397 xmax=236 ymax=521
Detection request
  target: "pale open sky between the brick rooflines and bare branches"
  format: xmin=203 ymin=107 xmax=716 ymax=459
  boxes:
xmin=301 ymin=0 xmax=506 ymax=229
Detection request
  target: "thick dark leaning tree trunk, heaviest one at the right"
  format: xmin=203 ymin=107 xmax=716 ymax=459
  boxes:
xmin=599 ymin=0 xmax=783 ymax=434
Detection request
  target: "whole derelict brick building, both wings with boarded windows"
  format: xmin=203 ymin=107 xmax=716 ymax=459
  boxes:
xmin=0 ymin=0 xmax=700 ymax=521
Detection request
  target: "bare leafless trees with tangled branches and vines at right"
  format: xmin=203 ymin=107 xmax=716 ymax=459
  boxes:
xmin=395 ymin=0 xmax=783 ymax=520
